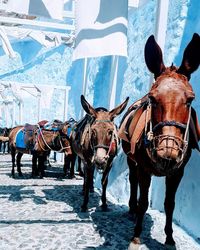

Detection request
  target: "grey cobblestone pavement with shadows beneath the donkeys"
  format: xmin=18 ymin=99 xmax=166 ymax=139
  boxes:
xmin=0 ymin=155 xmax=200 ymax=250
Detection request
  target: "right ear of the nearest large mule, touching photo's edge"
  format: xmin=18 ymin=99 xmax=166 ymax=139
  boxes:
xmin=177 ymin=33 xmax=200 ymax=80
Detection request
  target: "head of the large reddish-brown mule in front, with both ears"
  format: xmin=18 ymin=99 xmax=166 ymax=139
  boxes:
xmin=145 ymin=34 xmax=200 ymax=170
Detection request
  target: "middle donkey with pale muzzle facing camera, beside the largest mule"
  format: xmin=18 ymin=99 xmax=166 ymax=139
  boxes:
xmin=72 ymin=95 xmax=128 ymax=211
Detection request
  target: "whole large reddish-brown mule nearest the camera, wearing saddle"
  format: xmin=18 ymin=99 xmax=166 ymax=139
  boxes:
xmin=119 ymin=34 xmax=200 ymax=245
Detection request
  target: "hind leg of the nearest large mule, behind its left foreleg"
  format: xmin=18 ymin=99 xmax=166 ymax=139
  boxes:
xmin=127 ymin=157 xmax=138 ymax=217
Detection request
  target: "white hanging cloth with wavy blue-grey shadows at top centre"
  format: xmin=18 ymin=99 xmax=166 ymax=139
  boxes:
xmin=73 ymin=0 xmax=128 ymax=60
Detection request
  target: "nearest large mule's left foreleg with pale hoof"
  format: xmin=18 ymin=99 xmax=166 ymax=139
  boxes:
xmin=132 ymin=166 xmax=151 ymax=244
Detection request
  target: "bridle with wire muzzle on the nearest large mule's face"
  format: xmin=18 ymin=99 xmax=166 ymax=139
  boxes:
xmin=145 ymin=99 xmax=191 ymax=168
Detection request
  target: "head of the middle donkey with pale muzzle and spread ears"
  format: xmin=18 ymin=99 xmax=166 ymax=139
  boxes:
xmin=81 ymin=95 xmax=129 ymax=171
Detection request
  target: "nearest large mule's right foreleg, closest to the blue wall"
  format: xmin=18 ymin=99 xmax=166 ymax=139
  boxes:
xmin=164 ymin=168 xmax=184 ymax=246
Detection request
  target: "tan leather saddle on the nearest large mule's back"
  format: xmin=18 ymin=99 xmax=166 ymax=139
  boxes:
xmin=118 ymin=95 xmax=150 ymax=154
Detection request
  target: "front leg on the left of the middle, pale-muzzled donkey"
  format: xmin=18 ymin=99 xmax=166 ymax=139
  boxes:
xmin=81 ymin=167 xmax=93 ymax=212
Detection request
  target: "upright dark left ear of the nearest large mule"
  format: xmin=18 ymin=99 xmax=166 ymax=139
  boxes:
xmin=144 ymin=35 xmax=165 ymax=79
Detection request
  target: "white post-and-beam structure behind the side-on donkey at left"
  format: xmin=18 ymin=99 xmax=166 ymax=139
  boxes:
xmin=0 ymin=80 xmax=71 ymax=126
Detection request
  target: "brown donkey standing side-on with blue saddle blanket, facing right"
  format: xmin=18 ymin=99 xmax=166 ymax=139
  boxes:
xmin=9 ymin=119 xmax=71 ymax=177
